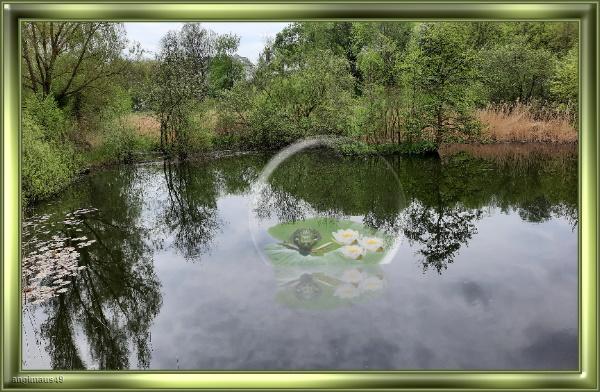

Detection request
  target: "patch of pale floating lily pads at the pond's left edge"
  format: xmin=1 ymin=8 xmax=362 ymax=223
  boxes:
xmin=22 ymin=208 xmax=97 ymax=305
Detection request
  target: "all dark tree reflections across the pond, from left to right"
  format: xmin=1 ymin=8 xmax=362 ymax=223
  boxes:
xmin=24 ymin=146 xmax=578 ymax=369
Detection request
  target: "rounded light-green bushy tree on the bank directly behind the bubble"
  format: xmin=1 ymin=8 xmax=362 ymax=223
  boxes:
xmin=250 ymin=49 xmax=353 ymax=147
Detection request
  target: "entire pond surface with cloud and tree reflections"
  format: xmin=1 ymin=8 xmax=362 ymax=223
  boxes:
xmin=22 ymin=147 xmax=579 ymax=370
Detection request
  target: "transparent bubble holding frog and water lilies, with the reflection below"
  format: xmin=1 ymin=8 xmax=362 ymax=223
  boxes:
xmin=248 ymin=137 xmax=405 ymax=308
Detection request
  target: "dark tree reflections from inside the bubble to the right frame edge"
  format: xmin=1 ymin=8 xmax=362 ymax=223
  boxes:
xmin=256 ymin=149 xmax=577 ymax=272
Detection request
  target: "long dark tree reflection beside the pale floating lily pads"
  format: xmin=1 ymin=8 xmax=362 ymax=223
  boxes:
xmin=33 ymin=170 xmax=162 ymax=369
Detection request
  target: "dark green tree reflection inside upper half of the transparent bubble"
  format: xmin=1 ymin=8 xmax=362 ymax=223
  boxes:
xmin=255 ymin=150 xmax=404 ymax=234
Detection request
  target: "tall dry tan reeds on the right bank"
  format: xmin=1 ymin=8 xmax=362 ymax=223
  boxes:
xmin=477 ymin=102 xmax=577 ymax=143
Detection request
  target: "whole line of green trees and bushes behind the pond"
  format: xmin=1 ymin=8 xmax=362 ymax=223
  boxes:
xmin=22 ymin=22 xmax=579 ymax=200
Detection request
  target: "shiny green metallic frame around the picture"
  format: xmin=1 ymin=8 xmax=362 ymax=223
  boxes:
xmin=0 ymin=0 xmax=599 ymax=390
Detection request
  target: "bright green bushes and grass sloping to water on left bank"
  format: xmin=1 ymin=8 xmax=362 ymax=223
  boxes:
xmin=22 ymin=96 xmax=159 ymax=205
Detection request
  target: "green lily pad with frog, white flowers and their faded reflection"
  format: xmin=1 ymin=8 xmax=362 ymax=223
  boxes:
xmin=265 ymin=218 xmax=393 ymax=310
